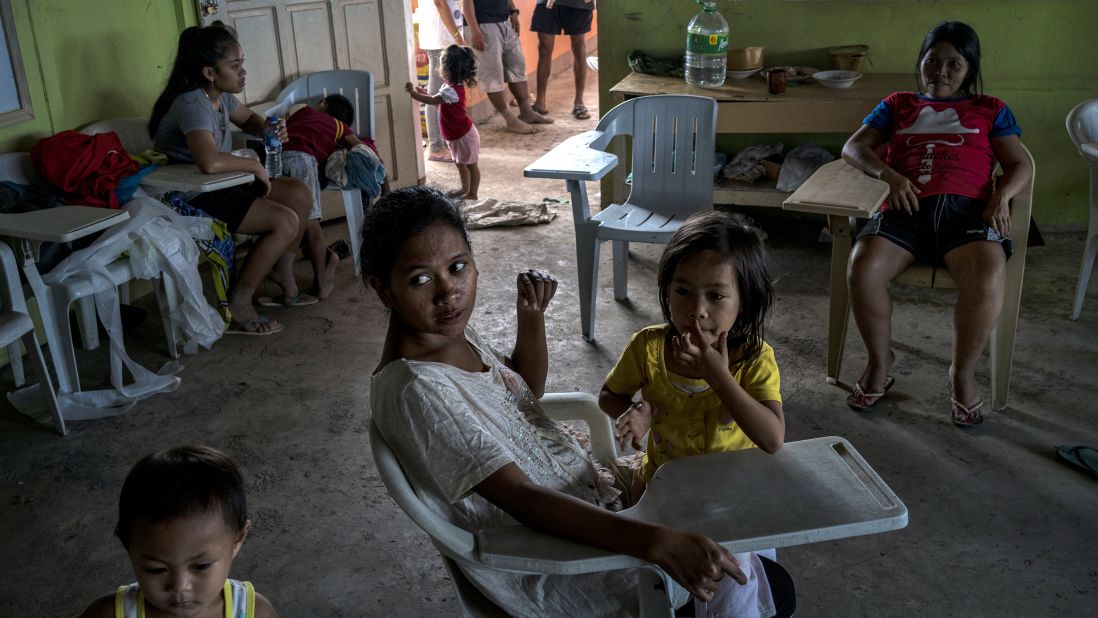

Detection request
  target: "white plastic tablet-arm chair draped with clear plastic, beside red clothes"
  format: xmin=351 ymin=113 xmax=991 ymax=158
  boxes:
xmin=0 ymin=153 xmax=178 ymax=393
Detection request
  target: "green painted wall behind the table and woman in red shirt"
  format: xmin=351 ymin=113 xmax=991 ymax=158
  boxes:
xmin=598 ymin=0 xmax=1098 ymax=229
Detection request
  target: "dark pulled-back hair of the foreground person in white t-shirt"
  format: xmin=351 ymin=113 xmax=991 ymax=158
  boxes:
xmin=359 ymin=186 xmax=472 ymax=285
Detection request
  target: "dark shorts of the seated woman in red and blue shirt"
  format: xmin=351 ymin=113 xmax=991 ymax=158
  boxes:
xmin=858 ymin=195 xmax=1013 ymax=263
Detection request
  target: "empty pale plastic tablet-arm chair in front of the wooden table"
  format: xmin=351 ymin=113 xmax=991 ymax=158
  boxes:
xmin=524 ymin=94 xmax=717 ymax=341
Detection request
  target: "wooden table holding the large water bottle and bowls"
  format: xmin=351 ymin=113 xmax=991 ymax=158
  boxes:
xmin=610 ymin=72 xmax=915 ymax=207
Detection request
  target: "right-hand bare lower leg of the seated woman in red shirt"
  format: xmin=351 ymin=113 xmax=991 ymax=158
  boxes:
xmin=945 ymin=241 xmax=1007 ymax=407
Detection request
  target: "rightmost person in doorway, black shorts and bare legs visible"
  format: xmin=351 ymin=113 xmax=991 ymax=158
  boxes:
xmin=530 ymin=0 xmax=595 ymax=120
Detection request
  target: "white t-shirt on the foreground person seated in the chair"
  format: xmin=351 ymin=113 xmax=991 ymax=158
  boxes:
xmin=370 ymin=327 xmax=638 ymax=618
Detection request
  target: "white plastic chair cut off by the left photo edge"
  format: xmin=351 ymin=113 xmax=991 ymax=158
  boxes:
xmin=0 ymin=243 xmax=68 ymax=436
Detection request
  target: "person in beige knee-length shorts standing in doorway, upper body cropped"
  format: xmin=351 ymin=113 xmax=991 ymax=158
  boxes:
xmin=461 ymin=0 xmax=552 ymax=133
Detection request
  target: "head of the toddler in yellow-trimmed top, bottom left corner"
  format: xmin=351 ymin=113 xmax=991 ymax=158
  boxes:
xmin=114 ymin=447 xmax=251 ymax=615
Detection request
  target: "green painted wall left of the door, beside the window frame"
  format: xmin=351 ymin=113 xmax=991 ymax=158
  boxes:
xmin=0 ymin=0 xmax=198 ymax=151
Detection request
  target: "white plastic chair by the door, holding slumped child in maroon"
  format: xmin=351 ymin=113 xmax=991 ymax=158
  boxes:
xmin=272 ymin=70 xmax=374 ymax=274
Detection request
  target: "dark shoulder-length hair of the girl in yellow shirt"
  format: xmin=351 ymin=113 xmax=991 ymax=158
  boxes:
xmin=658 ymin=211 xmax=774 ymax=364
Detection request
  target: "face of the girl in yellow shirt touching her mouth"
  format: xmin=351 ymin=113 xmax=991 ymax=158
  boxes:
xmin=668 ymin=250 xmax=741 ymax=346
